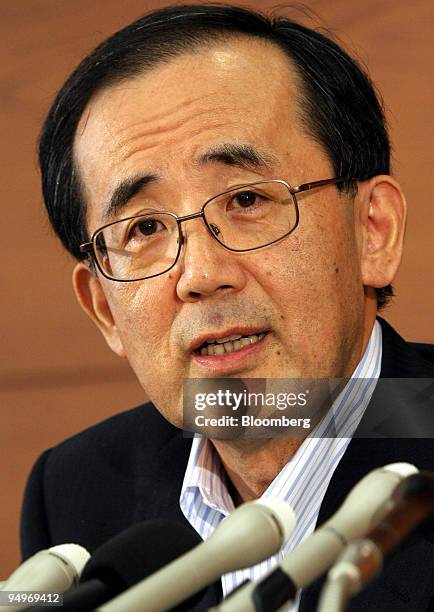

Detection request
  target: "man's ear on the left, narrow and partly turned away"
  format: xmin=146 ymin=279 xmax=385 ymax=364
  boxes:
xmin=72 ymin=262 xmax=125 ymax=357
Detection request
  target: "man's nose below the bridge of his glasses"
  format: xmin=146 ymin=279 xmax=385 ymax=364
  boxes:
xmin=176 ymin=219 xmax=246 ymax=302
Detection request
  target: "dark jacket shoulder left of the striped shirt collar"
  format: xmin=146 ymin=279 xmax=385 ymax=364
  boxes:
xmin=21 ymin=404 xmax=191 ymax=558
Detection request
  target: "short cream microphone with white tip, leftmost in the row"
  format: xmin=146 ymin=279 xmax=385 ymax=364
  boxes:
xmin=0 ymin=544 xmax=90 ymax=612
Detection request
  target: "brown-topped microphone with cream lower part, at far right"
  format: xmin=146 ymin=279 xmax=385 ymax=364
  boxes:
xmin=318 ymin=471 xmax=434 ymax=612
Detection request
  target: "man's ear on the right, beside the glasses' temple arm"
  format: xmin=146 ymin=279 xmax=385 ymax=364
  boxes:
xmin=360 ymin=175 xmax=407 ymax=288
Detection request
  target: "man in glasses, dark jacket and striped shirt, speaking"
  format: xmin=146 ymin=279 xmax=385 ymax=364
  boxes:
xmin=22 ymin=5 xmax=434 ymax=610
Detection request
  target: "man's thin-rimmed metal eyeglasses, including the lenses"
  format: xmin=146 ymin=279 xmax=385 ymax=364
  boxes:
xmin=80 ymin=178 xmax=350 ymax=282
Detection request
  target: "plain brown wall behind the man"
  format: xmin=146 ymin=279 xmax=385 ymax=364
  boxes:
xmin=0 ymin=0 xmax=434 ymax=580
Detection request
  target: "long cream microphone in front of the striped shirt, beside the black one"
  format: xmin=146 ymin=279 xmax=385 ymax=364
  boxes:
xmin=99 ymin=499 xmax=295 ymax=612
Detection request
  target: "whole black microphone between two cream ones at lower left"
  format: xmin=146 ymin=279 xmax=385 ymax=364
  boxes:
xmin=25 ymin=520 xmax=203 ymax=612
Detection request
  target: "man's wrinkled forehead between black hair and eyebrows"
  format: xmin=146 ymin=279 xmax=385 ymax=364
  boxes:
xmin=74 ymin=38 xmax=322 ymax=227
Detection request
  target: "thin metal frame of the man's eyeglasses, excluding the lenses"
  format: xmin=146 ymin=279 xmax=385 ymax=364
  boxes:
xmin=80 ymin=177 xmax=350 ymax=283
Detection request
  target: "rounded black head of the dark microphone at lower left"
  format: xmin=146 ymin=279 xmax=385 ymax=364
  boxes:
xmin=80 ymin=520 xmax=202 ymax=592
